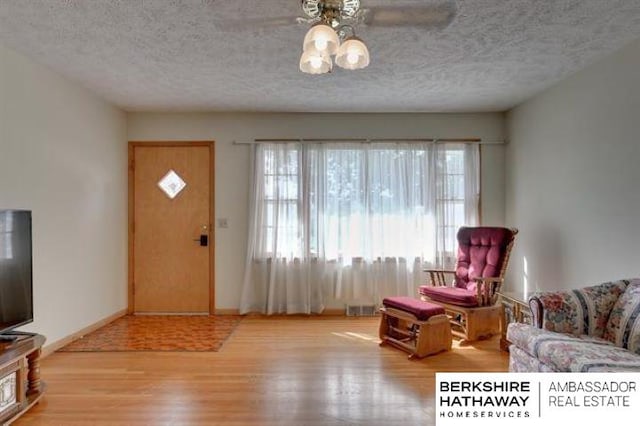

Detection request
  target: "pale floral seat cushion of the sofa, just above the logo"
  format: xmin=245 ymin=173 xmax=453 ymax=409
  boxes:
xmin=507 ymin=324 xmax=640 ymax=372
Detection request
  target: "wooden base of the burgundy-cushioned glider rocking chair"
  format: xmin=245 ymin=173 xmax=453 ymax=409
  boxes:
xmin=422 ymin=297 xmax=501 ymax=341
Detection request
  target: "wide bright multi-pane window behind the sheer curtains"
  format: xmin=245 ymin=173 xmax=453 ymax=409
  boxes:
xmin=254 ymin=143 xmax=477 ymax=263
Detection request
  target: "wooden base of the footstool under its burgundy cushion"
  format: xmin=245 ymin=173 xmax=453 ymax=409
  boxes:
xmin=379 ymin=307 xmax=451 ymax=359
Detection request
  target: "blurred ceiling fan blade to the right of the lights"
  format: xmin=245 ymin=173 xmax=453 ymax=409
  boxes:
xmin=363 ymin=1 xmax=458 ymax=29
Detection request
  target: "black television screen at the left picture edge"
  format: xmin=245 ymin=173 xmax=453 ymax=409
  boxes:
xmin=0 ymin=210 xmax=33 ymax=333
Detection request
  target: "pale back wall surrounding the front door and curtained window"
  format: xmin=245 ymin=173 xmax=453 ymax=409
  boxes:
xmin=128 ymin=113 xmax=504 ymax=309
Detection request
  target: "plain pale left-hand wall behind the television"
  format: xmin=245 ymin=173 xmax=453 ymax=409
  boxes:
xmin=0 ymin=46 xmax=127 ymax=343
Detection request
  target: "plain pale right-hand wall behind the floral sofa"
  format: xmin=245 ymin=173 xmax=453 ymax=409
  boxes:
xmin=506 ymin=41 xmax=640 ymax=290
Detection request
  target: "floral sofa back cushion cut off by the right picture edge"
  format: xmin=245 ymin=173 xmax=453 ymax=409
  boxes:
xmin=604 ymin=279 xmax=640 ymax=355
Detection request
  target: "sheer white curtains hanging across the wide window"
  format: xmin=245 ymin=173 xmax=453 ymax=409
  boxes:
xmin=240 ymin=143 xmax=479 ymax=314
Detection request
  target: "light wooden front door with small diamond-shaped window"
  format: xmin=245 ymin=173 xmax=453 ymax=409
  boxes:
xmin=129 ymin=142 xmax=214 ymax=314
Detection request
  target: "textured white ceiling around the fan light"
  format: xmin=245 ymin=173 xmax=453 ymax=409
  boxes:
xmin=0 ymin=0 xmax=640 ymax=112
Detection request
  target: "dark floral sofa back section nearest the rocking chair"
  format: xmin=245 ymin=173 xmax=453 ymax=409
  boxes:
xmin=534 ymin=280 xmax=630 ymax=337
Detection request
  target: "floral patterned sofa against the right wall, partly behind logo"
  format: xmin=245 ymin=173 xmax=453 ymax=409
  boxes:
xmin=507 ymin=279 xmax=640 ymax=372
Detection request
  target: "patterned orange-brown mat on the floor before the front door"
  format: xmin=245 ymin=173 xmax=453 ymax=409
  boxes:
xmin=58 ymin=315 xmax=242 ymax=352
